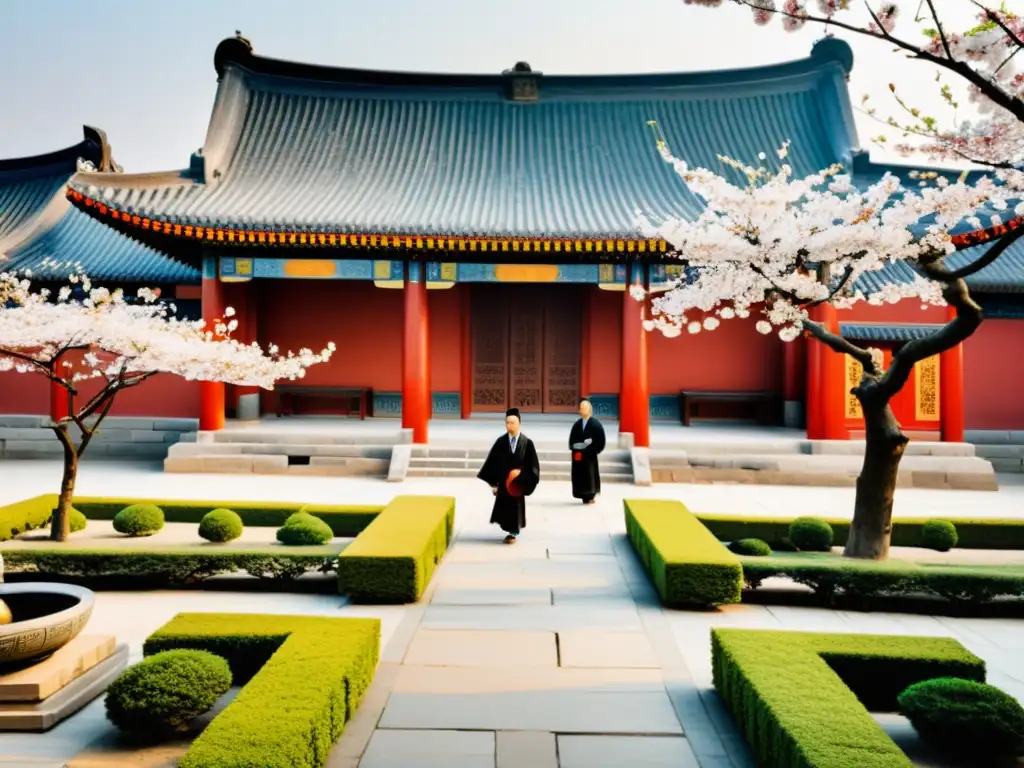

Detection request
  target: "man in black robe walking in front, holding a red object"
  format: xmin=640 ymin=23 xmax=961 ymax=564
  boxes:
xmin=476 ymin=408 xmax=541 ymax=544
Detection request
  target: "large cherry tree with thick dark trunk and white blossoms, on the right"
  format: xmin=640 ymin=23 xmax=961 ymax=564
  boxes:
xmin=633 ymin=142 xmax=1024 ymax=559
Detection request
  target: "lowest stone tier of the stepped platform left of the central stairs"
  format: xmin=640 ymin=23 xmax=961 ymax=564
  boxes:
xmin=164 ymin=454 xmax=391 ymax=477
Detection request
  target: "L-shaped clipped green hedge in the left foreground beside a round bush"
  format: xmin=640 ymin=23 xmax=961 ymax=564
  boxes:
xmin=143 ymin=613 xmax=380 ymax=768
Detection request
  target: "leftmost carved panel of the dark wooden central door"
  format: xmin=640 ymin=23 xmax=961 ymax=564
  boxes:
xmin=470 ymin=286 xmax=509 ymax=412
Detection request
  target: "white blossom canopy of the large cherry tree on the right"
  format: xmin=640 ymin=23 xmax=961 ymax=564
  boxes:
xmin=633 ymin=144 xmax=1007 ymax=341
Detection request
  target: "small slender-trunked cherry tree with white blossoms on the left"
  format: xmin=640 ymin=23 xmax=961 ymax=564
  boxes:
xmin=0 ymin=273 xmax=334 ymax=542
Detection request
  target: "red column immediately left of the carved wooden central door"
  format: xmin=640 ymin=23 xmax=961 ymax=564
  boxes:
xmin=401 ymin=261 xmax=431 ymax=443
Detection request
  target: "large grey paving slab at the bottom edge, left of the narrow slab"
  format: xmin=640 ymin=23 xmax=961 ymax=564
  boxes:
xmin=359 ymin=729 xmax=495 ymax=768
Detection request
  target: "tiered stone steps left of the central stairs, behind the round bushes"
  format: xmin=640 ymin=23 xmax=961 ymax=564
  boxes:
xmin=164 ymin=427 xmax=394 ymax=477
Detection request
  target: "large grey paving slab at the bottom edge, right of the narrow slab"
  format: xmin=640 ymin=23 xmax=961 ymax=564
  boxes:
xmin=558 ymin=734 xmax=700 ymax=768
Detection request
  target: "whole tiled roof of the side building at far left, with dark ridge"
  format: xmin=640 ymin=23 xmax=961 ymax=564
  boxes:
xmin=0 ymin=127 xmax=193 ymax=283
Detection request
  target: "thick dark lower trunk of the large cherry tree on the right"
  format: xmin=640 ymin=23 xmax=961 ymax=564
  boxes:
xmin=843 ymin=399 xmax=908 ymax=560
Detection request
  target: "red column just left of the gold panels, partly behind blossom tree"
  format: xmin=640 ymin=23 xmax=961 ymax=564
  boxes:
xmin=807 ymin=304 xmax=850 ymax=440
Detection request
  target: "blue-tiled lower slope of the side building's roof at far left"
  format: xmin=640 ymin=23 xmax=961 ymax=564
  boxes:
xmin=0 ymin=202 xmax=202 ymax=284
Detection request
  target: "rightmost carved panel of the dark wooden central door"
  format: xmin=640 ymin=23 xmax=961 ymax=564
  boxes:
xmin=544 ymin=286 xmax=583 ymax=413
